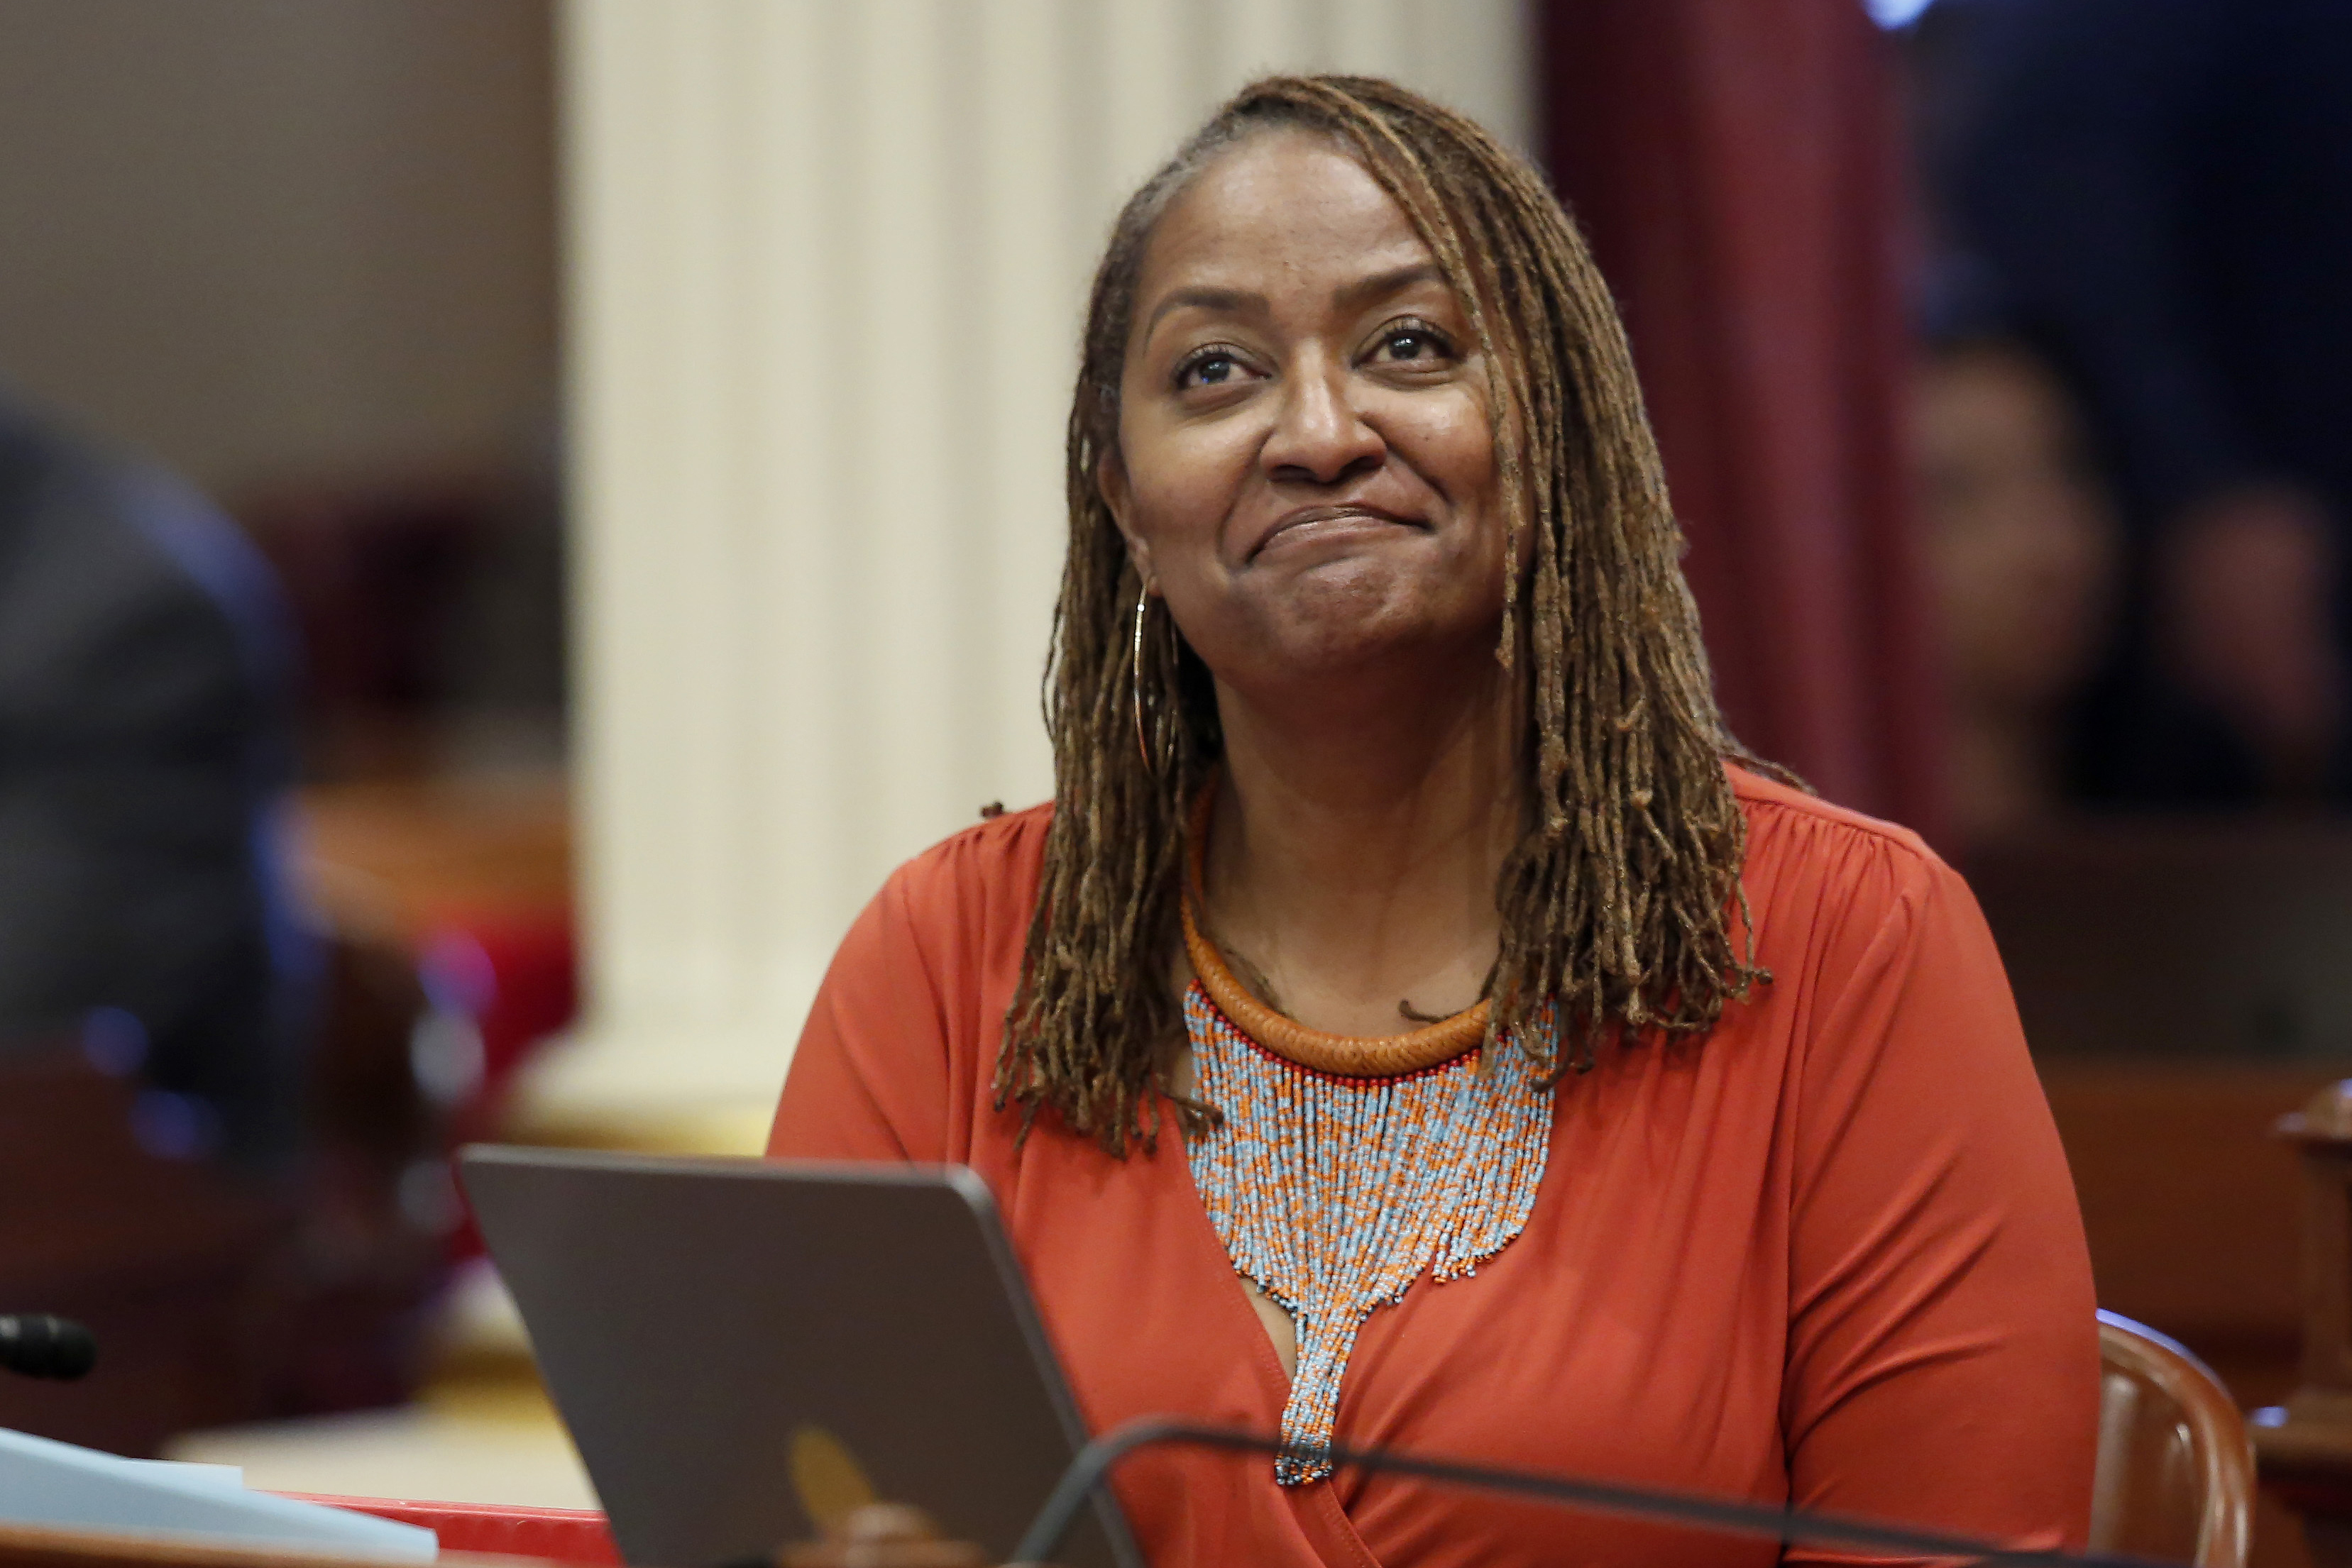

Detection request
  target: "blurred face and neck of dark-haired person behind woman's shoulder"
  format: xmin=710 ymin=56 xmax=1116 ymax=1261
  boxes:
xmin=1912 ymin=329 xmax=2121 ymax=844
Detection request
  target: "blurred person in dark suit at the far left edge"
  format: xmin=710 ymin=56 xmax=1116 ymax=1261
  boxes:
xmin=0 ymin=388 xmax=304 ymax=1169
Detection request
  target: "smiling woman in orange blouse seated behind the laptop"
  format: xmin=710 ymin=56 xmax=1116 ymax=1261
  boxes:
xmin=771 ymin=77 xmax=2096 ymax=1568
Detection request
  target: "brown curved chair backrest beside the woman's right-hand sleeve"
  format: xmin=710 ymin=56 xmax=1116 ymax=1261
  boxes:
xmin=2091 ymin=1312 xmax=2253 ymax=1568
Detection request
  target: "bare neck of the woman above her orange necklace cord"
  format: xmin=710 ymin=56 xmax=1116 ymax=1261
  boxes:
xmin=1204 ymin=656 xmax=1524 ymax=1034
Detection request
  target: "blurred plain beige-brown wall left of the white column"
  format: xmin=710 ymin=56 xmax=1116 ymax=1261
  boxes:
xmin=0 ymin=0 xmax=555 ymax=494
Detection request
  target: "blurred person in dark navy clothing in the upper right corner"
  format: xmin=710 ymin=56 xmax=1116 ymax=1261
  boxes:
xmin=1917 ymin=0 xmax=2352 ymax=804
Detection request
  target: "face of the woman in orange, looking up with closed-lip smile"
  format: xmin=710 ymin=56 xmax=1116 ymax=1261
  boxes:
xmin=1103 ymin=132 xmax=1503 ymax=689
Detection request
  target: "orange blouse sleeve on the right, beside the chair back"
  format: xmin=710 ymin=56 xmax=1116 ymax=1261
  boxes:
xmin=1783 ymin=834 xmax=2098 ymax=1561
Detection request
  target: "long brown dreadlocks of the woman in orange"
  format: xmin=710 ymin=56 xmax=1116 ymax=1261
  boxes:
xmin=995 ymin=75 xmax=1769 ymax=1156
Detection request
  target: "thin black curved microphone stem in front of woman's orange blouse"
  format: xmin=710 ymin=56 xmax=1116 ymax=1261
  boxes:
xmin=1013 ymin=1415 xmax=2159 ymax=1568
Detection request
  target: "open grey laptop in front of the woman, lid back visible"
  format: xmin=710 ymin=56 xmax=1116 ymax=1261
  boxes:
xmin=458 ymin=1147 xmax=1143 ymax=1568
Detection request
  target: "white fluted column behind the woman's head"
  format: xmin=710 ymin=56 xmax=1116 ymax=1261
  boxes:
xmin=527 ymin=0 xmax=1529 ymax=1147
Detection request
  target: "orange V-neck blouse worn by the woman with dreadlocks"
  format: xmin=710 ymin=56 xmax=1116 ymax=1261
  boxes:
xmin=769 ymin=771 xmax=2098 ymax=1568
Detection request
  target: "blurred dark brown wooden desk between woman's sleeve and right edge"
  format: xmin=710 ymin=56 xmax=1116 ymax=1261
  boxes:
xmin=1964 ymin=816 xmax=2352 ymax=1403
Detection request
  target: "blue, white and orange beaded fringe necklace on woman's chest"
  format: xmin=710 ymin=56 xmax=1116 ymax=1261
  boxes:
xmin=1183 ymin=800 xmax=1555 ymax=1486
